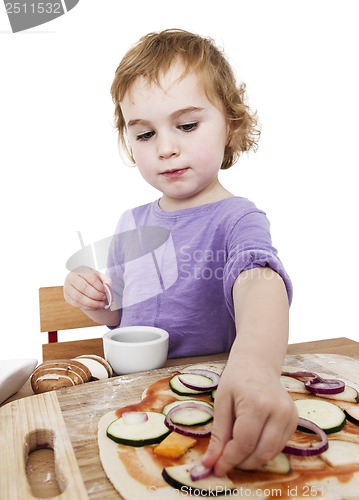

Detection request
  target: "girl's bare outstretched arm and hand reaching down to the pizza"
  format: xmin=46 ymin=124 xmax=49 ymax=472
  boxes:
xmin=203 ymin=267 xmax=298 ymax=476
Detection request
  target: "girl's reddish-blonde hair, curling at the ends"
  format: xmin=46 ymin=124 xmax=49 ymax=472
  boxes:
xmin=111 ymin=29 xmax=260 ymax=169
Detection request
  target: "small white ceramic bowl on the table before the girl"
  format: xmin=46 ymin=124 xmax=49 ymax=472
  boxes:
xmin=103 ymin=326 xmax=168 ymax=375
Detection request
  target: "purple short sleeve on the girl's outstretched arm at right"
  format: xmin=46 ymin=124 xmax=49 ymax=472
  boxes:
xmin=223 ymin=210 xmax=293 ymax=318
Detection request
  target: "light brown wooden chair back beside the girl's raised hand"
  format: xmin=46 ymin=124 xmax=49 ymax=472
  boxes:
xmin=39 ymin=286 xmax=104 ymax=361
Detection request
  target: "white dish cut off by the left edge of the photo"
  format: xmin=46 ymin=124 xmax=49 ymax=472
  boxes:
xmin=0 ymin=359 xmax=37 ymax=404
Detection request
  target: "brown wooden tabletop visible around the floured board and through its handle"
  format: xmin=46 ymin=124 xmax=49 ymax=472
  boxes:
xmin=0 ymin=337 xmax=359 ymax=498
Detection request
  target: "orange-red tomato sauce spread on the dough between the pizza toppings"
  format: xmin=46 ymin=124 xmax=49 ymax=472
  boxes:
xmin=111 ymin=375 xmax=359 ymax=500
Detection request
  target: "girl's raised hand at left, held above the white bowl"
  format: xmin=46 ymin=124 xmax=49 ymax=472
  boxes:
xmin=64 ymin=267 xmax=111 ymax=311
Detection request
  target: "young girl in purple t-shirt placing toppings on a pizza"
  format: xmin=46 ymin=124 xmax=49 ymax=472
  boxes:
xmin=64 ymin=30 xmax=297 ymax=475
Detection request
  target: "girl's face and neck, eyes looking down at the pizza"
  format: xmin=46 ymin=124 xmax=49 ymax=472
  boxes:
xmin=121 ymin=64 xmax=229 ymax=210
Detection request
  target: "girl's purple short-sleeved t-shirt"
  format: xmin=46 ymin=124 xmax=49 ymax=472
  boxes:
xmin=108 ymin=197 xmax=292 ymax=358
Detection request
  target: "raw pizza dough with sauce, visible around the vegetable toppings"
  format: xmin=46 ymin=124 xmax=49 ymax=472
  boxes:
xmin=98 ymin=365 xmax=359 ymax=500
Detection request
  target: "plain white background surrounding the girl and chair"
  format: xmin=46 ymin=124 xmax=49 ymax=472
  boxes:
xmin=0 ymin=0 xmax=359 ymax=360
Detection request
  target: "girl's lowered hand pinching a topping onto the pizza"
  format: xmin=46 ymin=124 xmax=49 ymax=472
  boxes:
xmin=202 ymin=363 xmax=298 ymax=476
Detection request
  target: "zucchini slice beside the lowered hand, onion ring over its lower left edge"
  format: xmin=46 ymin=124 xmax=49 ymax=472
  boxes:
xmin=294 ymin=399 xmax=346 ymax=434
